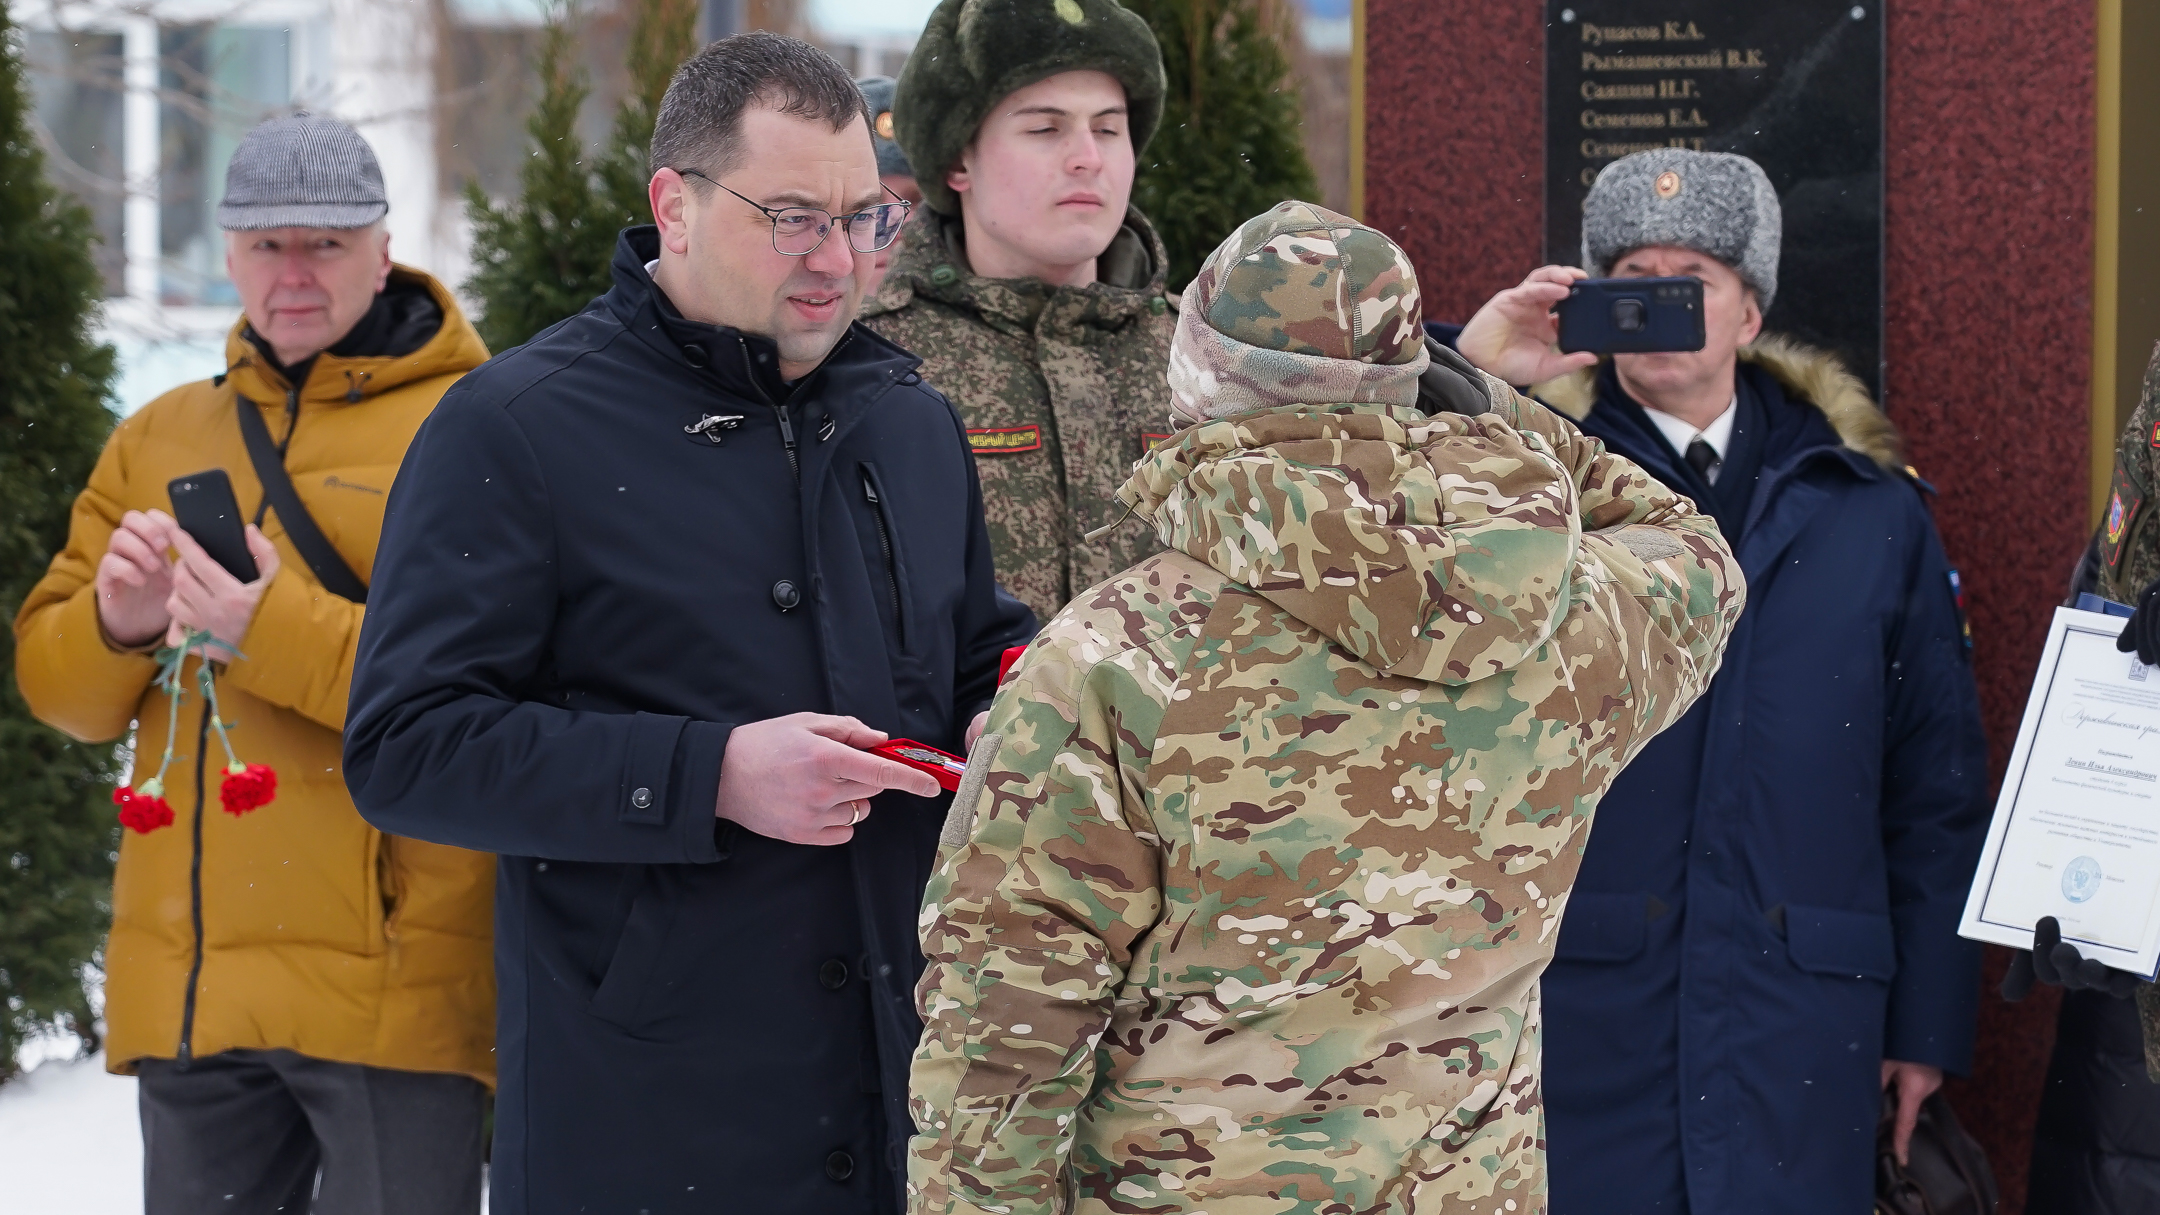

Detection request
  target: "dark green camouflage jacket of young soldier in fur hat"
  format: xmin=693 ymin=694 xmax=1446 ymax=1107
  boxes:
xmin=862 ymin=210 xmax=1175 ymax=620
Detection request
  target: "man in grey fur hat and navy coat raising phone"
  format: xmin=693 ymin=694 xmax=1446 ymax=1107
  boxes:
xmin=1458 ymin=149 xmax=1987 ymax=1215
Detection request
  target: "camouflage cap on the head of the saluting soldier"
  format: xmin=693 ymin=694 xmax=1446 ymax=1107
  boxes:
xmin=1169 ymin=201 xmax=1428 ymax=424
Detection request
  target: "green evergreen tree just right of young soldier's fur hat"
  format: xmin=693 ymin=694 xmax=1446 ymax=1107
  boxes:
xmin=1123 ymin=0 xmax=1320 ymax=290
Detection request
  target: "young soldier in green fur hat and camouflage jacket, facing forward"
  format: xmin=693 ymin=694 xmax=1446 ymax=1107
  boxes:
xmin=862 ymin=0 xmax=1175 ymax=620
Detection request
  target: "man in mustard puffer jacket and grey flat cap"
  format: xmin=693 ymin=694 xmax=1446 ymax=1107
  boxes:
xmin=15 ymin=115 xmax=495 ymax=1215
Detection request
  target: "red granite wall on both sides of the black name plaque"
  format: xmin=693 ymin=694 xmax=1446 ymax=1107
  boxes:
xmin=1365 ymin=0 xmax=2093 ymax=1213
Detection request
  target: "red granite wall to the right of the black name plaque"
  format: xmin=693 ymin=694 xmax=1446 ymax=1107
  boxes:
xmin=1884 ymin=0 xmax=2093 ymax=1211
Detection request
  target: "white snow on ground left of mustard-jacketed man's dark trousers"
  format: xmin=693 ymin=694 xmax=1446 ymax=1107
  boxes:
xmin=0 ymin=1053 xmax=143 ymax=1215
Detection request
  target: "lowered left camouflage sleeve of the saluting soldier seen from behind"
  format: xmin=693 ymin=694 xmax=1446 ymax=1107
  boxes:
xmin=907 ymin=588 xmax=1199 ymax=1215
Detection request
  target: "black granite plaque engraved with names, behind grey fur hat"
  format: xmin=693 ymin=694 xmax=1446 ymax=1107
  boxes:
xmin=1544 ymin=0 xmax=1884 ymax=400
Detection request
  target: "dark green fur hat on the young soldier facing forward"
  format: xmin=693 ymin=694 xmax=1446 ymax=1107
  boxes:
xmin=892 ymin=0 xmax=1164 ymax=216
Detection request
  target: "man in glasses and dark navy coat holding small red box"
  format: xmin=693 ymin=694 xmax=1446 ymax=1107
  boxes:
xmin=346 ymin=35 xmax=1035 ymax=1215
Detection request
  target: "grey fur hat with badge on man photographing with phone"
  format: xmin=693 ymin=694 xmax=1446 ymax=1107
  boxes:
xmin=1583 ymin=147 xmax=1784 ymax=311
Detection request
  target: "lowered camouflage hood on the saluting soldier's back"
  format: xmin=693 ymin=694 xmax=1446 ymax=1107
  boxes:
xmin=1119 ymin=404 xmax=1581 ymax=683
